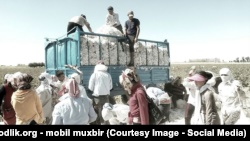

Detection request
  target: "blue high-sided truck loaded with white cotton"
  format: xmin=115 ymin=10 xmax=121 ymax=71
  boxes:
xmin=45 ymin=27 xmax=170 ymax=96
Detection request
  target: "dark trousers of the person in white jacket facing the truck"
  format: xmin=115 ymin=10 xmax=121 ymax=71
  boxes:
xmin=94 ymin=95 xmax=109 ymax=124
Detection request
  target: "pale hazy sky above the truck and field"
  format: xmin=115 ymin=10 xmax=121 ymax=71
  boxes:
xmin=0 ymin=0 xmax=250 ymax=65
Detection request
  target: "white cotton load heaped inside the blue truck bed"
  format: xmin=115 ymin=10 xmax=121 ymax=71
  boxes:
xmin=81 ymin=25 xmax=169 ymax=65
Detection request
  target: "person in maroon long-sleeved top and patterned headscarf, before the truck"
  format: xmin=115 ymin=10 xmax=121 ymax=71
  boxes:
xmin=119 ymin=68 xmax=149 ymax=125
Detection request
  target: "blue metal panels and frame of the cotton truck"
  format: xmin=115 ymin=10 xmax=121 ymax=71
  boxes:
xmin=45 ymin=29 xmax=170 ymax=95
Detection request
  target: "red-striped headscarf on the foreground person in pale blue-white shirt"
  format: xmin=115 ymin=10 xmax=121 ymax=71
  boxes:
xmin=65 ymin=79 xmax=80 ymax=98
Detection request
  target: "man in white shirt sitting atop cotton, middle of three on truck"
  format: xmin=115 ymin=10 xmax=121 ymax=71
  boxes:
xmin=106 ymin=6 xmax=123 ymax=34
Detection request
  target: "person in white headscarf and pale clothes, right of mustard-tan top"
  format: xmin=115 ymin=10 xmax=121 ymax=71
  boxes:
xmin=36 ymin=72 xmax=53 ymax=125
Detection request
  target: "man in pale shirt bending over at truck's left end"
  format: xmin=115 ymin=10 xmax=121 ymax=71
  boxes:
xmin=67 ymin=14 xmax=93 ymax=35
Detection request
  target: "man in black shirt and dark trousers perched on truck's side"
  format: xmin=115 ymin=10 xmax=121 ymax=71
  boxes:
xmin=124 ymin=11 xmax=140 ymax=66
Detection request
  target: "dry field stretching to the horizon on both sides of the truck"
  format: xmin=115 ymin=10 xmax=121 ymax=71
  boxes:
xmin=0 ymin=63 xmax=250 ymax=88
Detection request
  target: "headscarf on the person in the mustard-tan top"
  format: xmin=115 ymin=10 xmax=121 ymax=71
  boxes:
xmin=14 ymin=73 xmax=33 ymax=90
